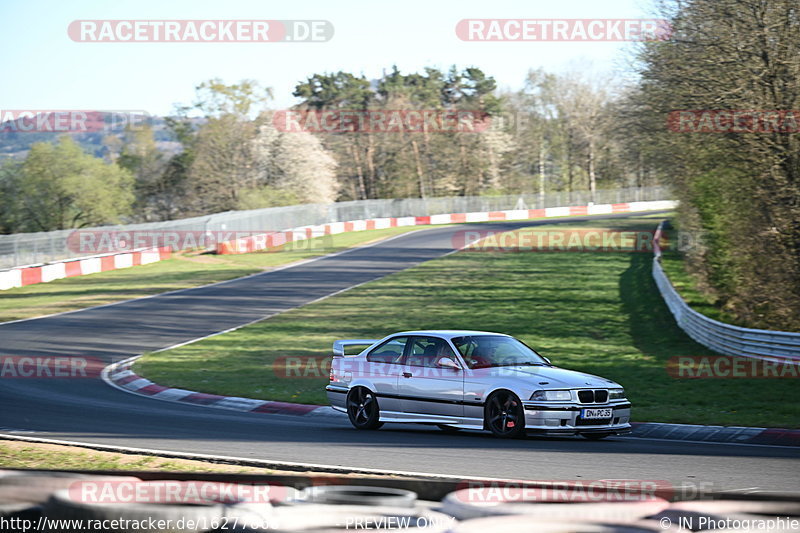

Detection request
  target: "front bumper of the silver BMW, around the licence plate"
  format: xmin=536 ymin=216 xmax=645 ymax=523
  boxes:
xmin=522 ymin=401 xmax=631 ymax=435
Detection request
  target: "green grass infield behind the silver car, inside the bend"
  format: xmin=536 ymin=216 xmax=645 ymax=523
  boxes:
xmin=136 ymin=217 xmax=800 ymax=427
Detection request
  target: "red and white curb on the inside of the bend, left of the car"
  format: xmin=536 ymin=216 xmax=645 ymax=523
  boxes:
xmin=102 ymin=355 xmax=347 ymax=418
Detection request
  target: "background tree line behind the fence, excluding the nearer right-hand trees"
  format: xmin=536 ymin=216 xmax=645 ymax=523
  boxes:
xmin=0 ymin=67 xmax=658 ymax=233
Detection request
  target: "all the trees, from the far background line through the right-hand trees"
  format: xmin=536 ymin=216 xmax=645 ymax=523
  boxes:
xmin=0 ymin=0 xmax=800 ymax=329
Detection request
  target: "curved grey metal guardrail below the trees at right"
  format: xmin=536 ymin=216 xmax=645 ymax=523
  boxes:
xmin=653 ymin=222 xmax=800 ymax=363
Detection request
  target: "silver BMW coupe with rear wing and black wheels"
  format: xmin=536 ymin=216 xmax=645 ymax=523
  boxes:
xmin=326 ymin=330 xmax=631 ymax=439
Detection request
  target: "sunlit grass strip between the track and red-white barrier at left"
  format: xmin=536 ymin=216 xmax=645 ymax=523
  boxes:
xmin=0 ymin=226 xmax=430 ymax=322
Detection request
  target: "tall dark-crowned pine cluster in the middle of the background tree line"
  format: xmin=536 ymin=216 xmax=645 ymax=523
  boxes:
xmin=294 ymin=67 xmax=509 ymax=199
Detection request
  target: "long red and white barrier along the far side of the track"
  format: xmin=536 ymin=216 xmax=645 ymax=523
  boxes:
xmin=216 ymin=200 xmax=675 ymax=254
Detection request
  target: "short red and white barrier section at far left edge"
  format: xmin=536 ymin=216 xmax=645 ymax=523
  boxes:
xmin=0 ymin=247 xmax=172 ymax=290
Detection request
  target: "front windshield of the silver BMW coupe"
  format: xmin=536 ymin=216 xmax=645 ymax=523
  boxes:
xmin=453 ymin=335 xmax=547 ymax=369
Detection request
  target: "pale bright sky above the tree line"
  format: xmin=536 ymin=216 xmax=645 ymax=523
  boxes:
xmin=0 ymin=0 xmax=652 ymax=115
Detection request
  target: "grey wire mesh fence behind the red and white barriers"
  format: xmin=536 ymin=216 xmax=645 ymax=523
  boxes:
xmin=0 ymin=187 xmax=672 ymax=269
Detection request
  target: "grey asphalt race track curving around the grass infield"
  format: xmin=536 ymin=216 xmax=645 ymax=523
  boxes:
xmin=0 ymin=215 xmax=800 ymax=490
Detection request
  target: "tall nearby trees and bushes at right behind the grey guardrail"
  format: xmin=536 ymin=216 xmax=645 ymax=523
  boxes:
xmin=631 ymin=0 xmax=800 ymax=330
